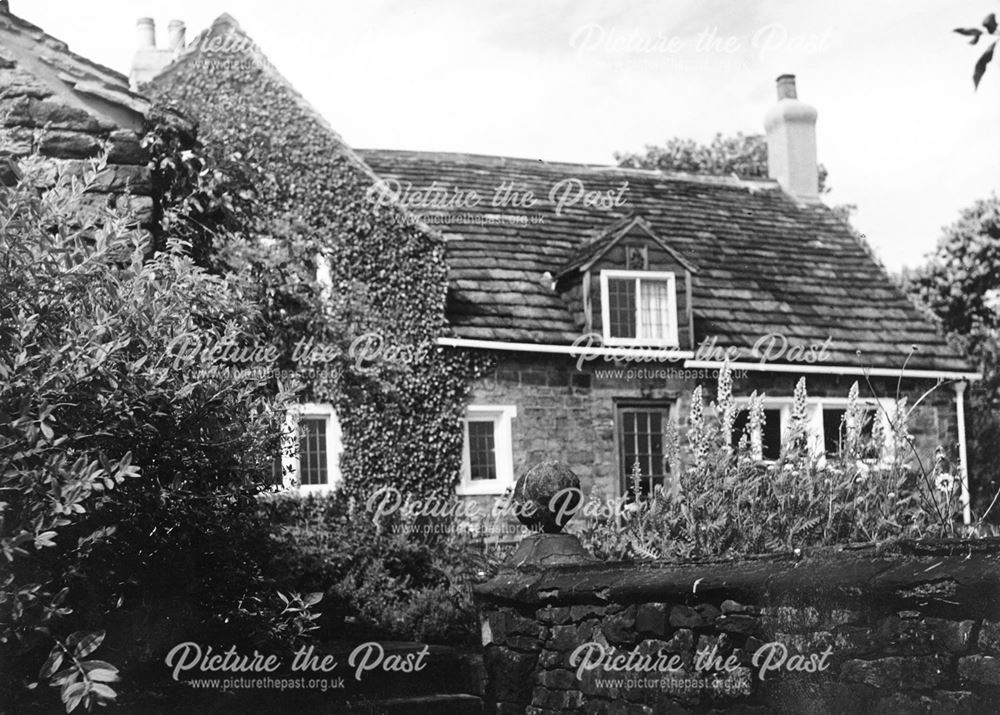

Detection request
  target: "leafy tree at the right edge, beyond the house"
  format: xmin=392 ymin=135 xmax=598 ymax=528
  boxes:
xmin=904 ymin=194 xmax=1000 ymax=519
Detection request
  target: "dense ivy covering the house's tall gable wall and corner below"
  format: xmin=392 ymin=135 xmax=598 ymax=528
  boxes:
xmin=151 ymin=25 xmax=488 ymax=504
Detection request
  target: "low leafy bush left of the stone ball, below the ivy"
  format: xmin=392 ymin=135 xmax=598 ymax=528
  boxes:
xmin=261 ymin=493 xmax=496 ymax=643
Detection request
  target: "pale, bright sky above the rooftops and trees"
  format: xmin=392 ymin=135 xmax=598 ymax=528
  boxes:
xmin=10 ymin=0 xmax=1000 ymax=271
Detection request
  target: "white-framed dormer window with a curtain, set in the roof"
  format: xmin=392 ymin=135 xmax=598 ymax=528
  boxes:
xmin=601 ymin=271 xmax=678 ymax=347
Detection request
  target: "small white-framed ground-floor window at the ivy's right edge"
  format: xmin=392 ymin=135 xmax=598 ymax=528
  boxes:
xmin=457 ymin=405 xmax=517 ymax=495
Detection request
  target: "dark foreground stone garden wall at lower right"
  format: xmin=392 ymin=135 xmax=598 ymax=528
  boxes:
xmin=477 ymin=535 xmax=1000 ymax=715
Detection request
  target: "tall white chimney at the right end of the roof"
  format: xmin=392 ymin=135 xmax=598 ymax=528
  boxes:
xmin=764 ymin=74 xmax=819 ymax=201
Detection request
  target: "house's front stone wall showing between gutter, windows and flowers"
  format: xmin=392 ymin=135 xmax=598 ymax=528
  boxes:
xmin=470 ymin=353 xmax=957 ymax=499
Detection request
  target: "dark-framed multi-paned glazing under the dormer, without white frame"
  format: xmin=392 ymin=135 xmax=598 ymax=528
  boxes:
xmin=618 ymin=405 xmax=670 ymax=496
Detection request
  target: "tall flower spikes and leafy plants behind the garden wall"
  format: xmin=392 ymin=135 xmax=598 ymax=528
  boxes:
xmin=581 ymin=367 xmax=976 ymax=559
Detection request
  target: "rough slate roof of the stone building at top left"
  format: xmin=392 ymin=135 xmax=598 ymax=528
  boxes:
xmin=0 ymin=8 xmax=149 ymax=132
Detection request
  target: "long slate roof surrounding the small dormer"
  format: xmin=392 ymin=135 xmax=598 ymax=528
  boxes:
xmin=358 ymin=149 xmax=973 ymax=371
